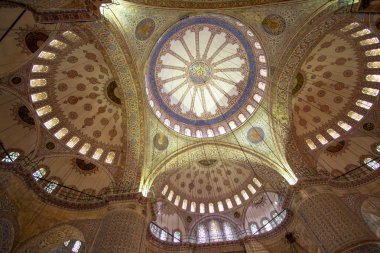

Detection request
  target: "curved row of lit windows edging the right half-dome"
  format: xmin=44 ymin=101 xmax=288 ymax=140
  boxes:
xmin=305 ymin=22 xmax=380 ymax=150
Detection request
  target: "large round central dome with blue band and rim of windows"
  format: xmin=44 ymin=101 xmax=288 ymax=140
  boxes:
xmin=146 ymin=15 xmax=267 ymax=138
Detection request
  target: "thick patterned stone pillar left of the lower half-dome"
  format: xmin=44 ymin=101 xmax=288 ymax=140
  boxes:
xmin=90 ymin=198 xmax=150 ymax=253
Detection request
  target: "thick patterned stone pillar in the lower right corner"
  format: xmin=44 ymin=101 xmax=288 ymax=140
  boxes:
xmin=297 ymin=193 xmax=376 ymax=253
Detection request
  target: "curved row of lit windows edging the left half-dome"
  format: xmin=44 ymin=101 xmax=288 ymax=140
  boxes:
xmin=29 ymin=31 xmax=116 ymax=164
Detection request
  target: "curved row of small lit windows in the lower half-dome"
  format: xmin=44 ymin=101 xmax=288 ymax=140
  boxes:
xmin=161 ymin=178 xmax=262 ymax=214
